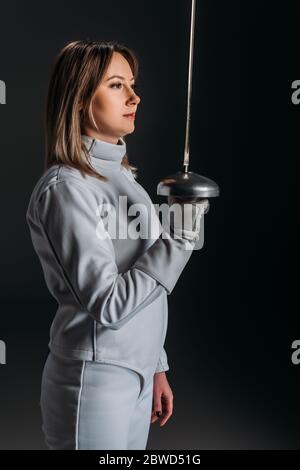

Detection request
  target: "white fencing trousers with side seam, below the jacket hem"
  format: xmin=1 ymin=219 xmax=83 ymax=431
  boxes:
xmin=40 ymin=352 xmax=153 ymax=450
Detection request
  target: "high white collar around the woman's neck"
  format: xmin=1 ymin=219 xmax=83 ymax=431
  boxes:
xmin=81 ymin=134 xmax=126 ymax=170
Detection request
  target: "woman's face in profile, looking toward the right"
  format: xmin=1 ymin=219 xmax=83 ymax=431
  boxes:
xmin=83 ymin=52 xmax=141 ymax=144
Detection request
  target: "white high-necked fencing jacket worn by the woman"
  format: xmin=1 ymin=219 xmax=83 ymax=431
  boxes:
xmin=26 ymin=135 xmax=192 ymax=375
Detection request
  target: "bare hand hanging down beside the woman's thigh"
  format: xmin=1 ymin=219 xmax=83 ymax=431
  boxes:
xmin=151 ymin=372 xmax=173 ymax=427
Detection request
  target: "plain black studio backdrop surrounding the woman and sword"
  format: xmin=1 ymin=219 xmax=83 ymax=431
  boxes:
xmin=0 ymin=0 xmax=300 ymax=449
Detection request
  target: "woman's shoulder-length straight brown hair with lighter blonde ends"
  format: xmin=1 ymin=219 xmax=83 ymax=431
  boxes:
xmin=45 ymin=40 xmax=138 ymax=181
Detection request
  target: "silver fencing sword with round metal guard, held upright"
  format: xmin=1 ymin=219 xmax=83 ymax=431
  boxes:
xmin=157 ymin=0 xmax=219 ymax=212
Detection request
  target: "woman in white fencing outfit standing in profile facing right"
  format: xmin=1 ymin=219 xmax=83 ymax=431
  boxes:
xmin=27 ymin=41 xmax=204 ymax=449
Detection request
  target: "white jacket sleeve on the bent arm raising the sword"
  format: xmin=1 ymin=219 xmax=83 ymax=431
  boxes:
xmin=37 ymin=180 xmax=192 ymax=329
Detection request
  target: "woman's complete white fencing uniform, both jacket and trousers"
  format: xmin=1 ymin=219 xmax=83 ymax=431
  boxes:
xmin=26 ymin=135 xmax=192 ymax=449
